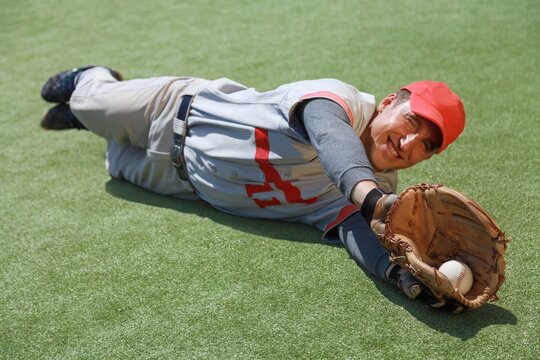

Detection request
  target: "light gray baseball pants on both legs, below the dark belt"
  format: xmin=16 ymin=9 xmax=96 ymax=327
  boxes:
xmin=70 ymin=67 xmax=203 ymax=199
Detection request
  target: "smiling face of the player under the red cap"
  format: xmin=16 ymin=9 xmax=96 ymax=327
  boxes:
xmin=362 ymin=94 xmax=442 ymax=171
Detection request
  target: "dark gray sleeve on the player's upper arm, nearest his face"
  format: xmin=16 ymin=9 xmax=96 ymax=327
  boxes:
xmin=296 ymin=99 xmax=376 ymax=199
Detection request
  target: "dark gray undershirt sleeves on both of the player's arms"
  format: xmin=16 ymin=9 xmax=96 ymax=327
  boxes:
xmin=295 ymin=99 xmax=390 ymax=280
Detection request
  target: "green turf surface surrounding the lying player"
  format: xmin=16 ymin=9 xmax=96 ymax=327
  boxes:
xmin=0 ymin=0 xmax=540 ymax=359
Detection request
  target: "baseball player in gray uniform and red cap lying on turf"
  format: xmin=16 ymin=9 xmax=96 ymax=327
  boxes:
xmin=41 ymin=66 xmax=465 ymax=304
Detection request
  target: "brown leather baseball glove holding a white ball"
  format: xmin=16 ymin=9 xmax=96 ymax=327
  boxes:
xmin=379 ymin=184 xmax=510 ymax=312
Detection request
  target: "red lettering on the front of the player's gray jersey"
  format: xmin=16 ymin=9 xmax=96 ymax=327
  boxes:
xmin=246 ymin=128 xmax=317 ymax=208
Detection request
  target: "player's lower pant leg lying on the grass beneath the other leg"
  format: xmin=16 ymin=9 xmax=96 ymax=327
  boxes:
xmin=106 ymin=141 xmax=198 ymax=199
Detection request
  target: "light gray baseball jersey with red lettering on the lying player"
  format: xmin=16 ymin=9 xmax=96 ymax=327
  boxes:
xmin=184 ymin=79 xmax=396 ymax=229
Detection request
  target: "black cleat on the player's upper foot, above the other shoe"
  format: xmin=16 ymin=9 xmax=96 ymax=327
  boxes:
xmin=41 ymin=65 xmax=123 ymax=104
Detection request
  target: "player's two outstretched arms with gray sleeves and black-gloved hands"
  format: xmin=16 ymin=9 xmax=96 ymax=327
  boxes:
xmin=296 ymin=99 xmax=428 ymax=304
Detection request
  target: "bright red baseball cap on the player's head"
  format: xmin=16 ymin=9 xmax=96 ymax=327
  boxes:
xmin=401 ymin=80 xmax=465 ymax=154
